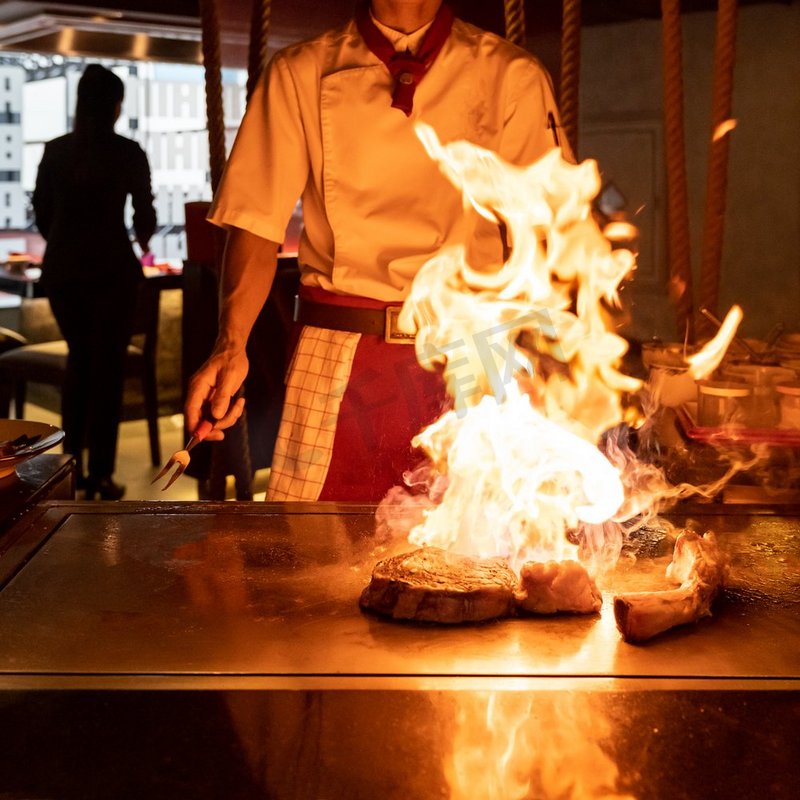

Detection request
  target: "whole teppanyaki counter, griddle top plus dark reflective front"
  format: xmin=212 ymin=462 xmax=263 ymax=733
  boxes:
xmin=0 ymin=503 xmax=800 ymax=800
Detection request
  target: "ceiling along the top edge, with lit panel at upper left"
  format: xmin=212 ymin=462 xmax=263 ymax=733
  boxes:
xmin=0 ymin=0 xmax=797 ymax=66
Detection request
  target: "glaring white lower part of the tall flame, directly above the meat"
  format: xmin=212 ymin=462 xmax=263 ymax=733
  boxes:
xmin=409 ymin=385 xmax=624 ymax=569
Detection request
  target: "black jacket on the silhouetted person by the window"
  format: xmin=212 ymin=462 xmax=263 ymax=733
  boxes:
xmin=33 ymin=132 xmax=156 ymax=290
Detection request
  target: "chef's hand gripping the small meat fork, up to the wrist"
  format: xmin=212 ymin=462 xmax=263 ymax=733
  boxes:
xmin=183 ymin=347 xmax=250 ymax=442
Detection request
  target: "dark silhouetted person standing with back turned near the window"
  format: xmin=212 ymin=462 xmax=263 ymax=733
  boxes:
xmin=33 ymin=64 xmax=156 ymax=500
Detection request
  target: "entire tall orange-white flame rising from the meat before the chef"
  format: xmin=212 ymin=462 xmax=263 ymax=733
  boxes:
xmin=400 ymin=124 xmax=641 ymax=567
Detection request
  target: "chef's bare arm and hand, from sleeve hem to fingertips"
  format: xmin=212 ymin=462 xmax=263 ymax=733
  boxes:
xmin=184 ymin=228 xmax=279 ymax=440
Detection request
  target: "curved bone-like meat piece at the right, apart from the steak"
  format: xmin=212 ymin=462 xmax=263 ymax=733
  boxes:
xmin=614 ymin=531 xmax=728 ymax=642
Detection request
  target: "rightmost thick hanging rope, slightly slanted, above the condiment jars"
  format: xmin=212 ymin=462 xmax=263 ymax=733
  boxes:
xmin=697 ymin=0 xmax=736 ymax=330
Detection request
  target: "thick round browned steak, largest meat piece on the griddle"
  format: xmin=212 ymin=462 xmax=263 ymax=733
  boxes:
xmin=360 ymin=547 xmax=517 ymax=624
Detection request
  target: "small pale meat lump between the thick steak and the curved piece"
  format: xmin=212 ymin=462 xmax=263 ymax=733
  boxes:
xmin=516 ymin=561 xmax=603 ymax=614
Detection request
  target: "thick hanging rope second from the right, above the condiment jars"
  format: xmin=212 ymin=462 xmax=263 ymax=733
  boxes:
xmin=661 ymin=0 xmax=694 ymax=341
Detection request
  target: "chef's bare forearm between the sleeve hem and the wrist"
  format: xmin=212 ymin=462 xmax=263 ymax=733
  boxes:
xmin=216 ymin=228 xmax=279 ymax=351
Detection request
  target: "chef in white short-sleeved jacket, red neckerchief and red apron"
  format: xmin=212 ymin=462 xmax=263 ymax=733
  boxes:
xmin=185 ymin=0 xmax=563 ymax=501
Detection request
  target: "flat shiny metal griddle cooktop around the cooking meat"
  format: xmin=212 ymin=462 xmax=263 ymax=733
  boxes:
xmin=0 ymin=503 xmax=800 ymax=687
